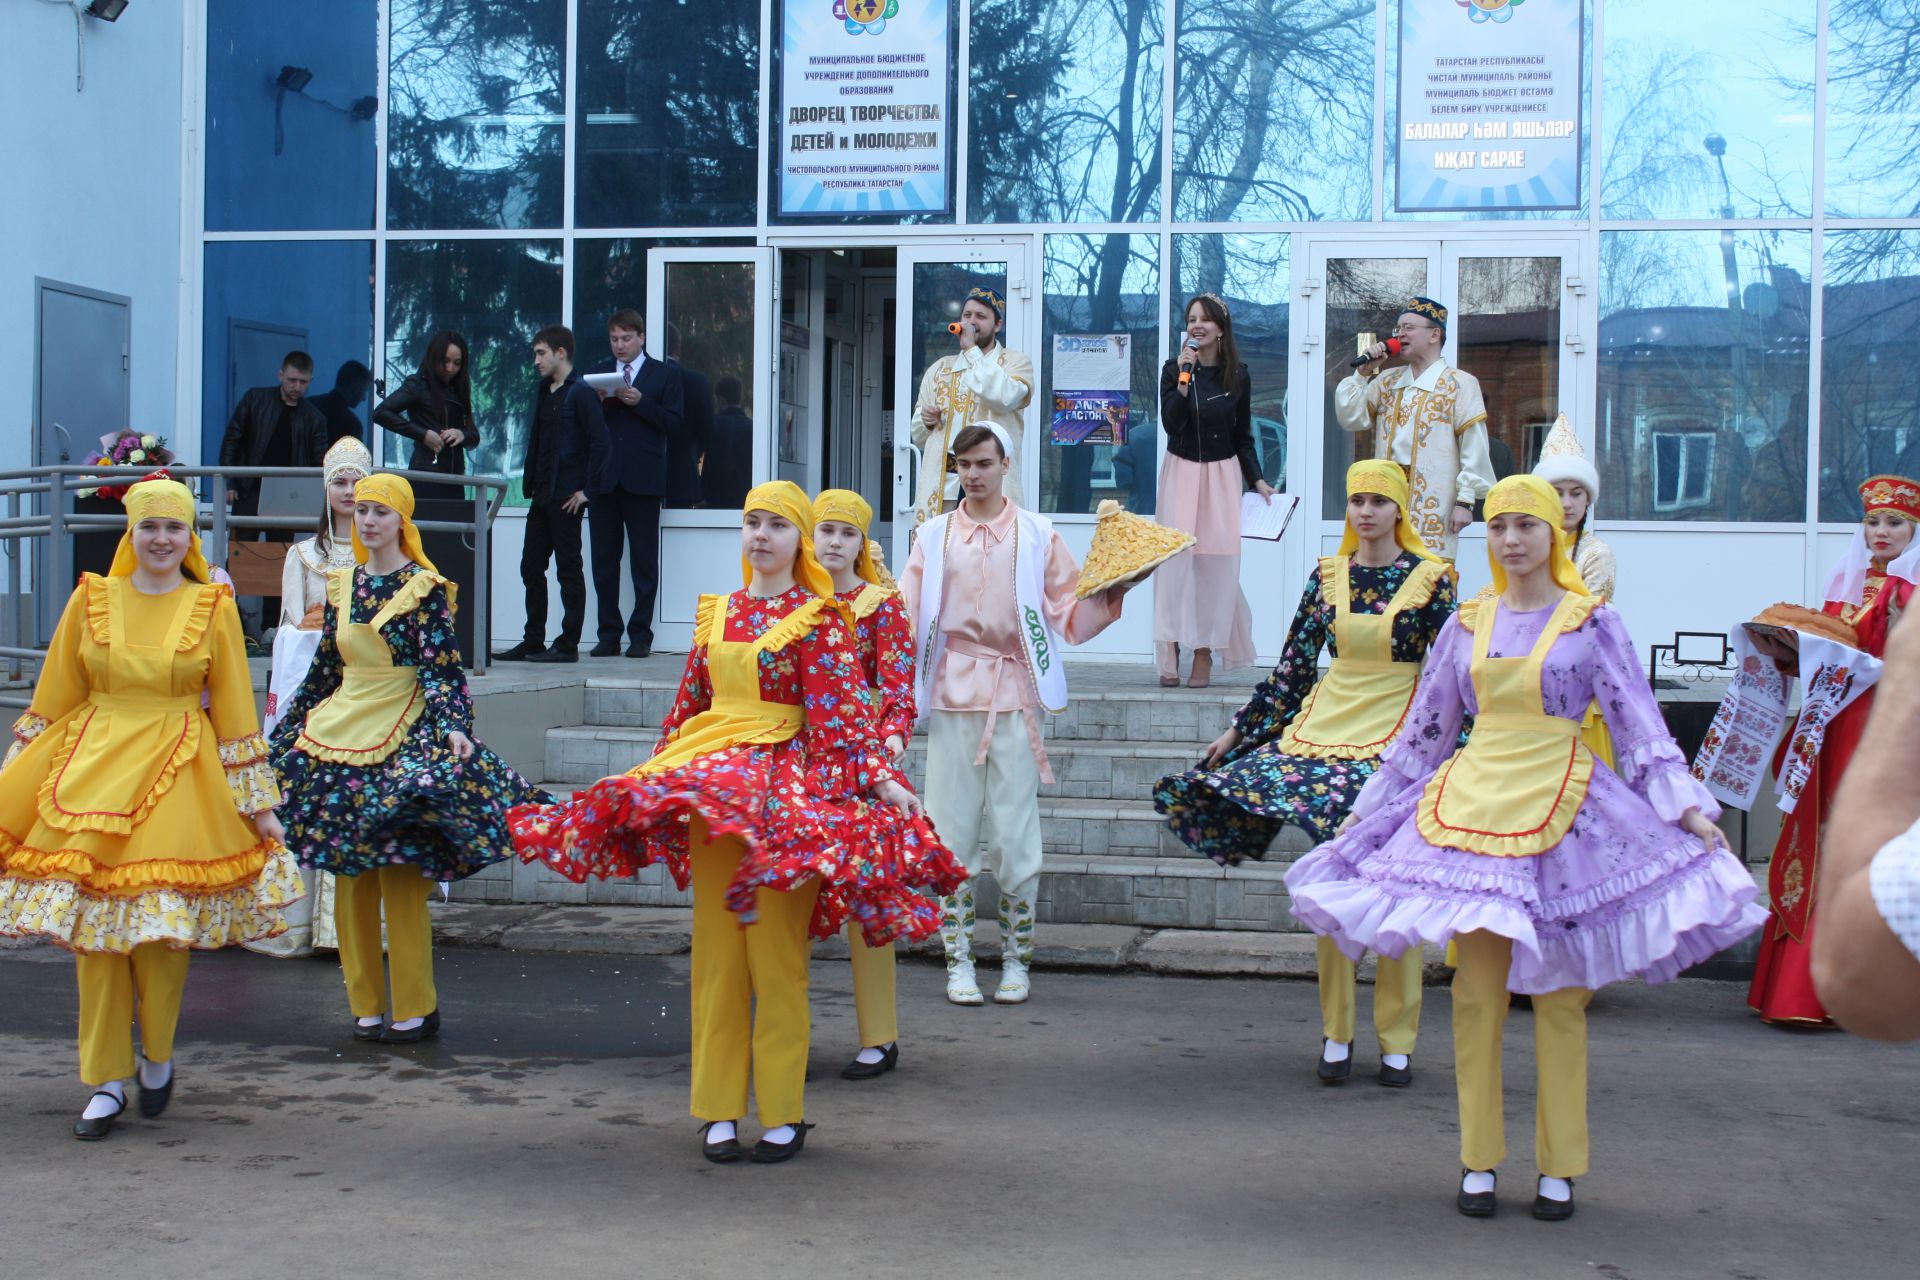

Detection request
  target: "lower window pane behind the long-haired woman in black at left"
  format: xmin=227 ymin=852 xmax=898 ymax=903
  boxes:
xmin=374 ymin=240 xmax=561 ymax=503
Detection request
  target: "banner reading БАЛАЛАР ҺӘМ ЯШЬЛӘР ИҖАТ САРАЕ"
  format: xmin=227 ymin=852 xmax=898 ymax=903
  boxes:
xmin=1394 ymin=0 xmax=1586 ymax=213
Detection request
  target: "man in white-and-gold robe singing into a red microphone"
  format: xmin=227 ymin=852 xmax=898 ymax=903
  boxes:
xmin=1332 ymin=297 xmax=1494 ymax=560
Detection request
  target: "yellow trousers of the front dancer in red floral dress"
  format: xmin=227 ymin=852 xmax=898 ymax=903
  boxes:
xmin=687 ymin=818 xmax=820 ymax=1128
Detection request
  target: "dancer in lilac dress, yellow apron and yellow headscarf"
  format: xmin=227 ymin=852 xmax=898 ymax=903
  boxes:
xmin=1286 ymin=476 xmax=1763 ymax=1221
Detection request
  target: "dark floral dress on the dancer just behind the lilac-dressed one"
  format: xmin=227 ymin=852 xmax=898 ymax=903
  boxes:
xmin=1154 ymin=553 xmax=1453 ymax=865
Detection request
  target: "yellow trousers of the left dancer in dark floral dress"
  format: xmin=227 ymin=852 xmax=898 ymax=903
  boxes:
xmin=334 ymin=865 xmax=440 ymax=1023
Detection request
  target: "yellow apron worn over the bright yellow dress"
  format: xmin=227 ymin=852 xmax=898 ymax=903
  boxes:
xmin=38 ymin=578 xmax=205 ymax=835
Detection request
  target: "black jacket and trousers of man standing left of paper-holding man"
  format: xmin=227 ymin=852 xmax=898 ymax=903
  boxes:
xmin=520 ymin=372 xmax=607 ymax=651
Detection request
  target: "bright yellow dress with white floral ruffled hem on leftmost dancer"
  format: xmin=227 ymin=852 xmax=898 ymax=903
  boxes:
xmin=0 ymin=574 xmax=301 ymax=954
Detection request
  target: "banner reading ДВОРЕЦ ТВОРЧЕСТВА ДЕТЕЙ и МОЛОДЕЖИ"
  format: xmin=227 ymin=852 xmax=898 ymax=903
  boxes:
xmin=774 ymin=0 xmax=954 ymax=217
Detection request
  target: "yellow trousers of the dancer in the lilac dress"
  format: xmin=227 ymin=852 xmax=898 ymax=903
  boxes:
xmin=1453 ymin=931 xmax=1594 ymax=1178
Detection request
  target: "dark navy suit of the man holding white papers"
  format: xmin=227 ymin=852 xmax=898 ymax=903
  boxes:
xmin=588 ymin=357 xmax=685 ymax=649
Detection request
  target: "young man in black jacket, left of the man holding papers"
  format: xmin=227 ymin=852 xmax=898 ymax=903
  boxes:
xmin=499 ymin=324 xmax=607 ymax=662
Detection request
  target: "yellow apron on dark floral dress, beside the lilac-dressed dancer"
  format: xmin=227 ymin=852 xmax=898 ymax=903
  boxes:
xmin=1281 ymin=557 xmax=1446 ymax=760
